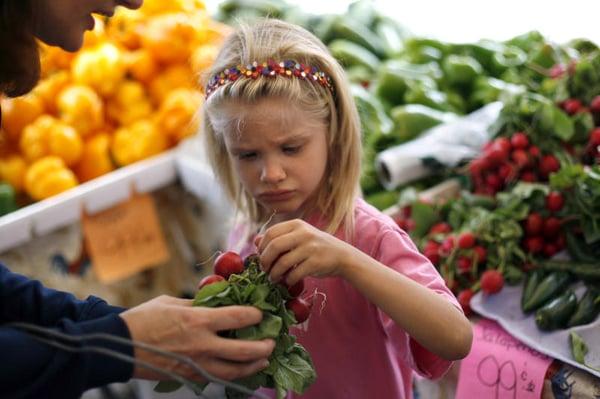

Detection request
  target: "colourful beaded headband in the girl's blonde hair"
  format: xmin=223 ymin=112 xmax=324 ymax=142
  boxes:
xmin=206 ymin=60 xmax=335 ymax=98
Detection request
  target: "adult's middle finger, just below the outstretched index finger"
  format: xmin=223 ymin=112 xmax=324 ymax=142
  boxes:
xmin=209 ymin=337 xmax=275 ymax=362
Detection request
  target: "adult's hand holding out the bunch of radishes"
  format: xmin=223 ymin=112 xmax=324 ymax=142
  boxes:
xmin=120 ymin=295 xmax=275 ymax=381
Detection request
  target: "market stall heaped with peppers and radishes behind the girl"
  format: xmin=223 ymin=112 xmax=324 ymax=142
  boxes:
xmin=0 ymin=0 xmax=600 ymax=399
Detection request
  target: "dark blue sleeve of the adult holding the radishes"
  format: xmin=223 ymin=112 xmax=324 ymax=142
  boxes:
xmin=0 ymin=264 xmax=133 ymax=399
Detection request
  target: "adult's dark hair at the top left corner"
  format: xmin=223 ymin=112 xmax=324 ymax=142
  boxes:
xmin=0 ymin=0 xmax=40 ymax=97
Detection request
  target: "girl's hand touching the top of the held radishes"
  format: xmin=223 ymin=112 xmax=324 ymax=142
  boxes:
xmin=255 ymin=219 xmax=355 ymax=286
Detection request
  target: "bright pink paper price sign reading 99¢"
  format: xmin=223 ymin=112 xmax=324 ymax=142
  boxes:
xmin=456 ymin=319 xmax=553 ymax=399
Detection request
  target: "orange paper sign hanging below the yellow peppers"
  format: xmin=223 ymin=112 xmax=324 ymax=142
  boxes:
xmin=82 ymin=194 xmax=169 ymax=283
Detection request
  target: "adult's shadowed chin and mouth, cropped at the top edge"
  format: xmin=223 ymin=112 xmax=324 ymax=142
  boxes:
xmin=33 ymin=0 xmax=143 ymax=51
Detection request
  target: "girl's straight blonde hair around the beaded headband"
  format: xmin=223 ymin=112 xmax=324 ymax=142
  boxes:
xmin=201 ymin=19 xmax=362 ymax=237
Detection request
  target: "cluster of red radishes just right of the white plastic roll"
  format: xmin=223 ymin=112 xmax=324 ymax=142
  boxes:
xmin=469 ymin=132 xmax=560 ymax=195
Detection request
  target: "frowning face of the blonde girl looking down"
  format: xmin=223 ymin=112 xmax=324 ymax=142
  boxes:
xmin=225 ymin=98 xmax=327 ymax=220
